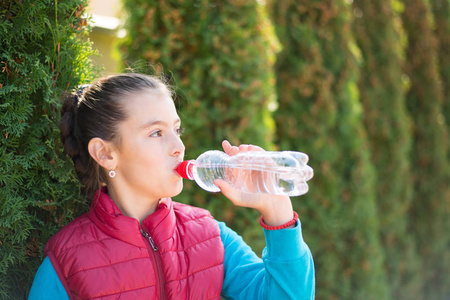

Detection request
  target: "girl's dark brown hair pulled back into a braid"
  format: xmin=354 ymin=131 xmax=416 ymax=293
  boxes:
xmin=61 ymin=73 xmax=170 ymax=199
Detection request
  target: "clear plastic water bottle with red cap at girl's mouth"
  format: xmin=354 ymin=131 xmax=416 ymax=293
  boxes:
xmin=176 ymin=150 xmax=313 ymax=196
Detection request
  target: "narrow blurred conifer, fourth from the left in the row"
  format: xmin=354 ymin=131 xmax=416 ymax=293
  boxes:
xmin=353 ymin=0 xmax=422 ymax=300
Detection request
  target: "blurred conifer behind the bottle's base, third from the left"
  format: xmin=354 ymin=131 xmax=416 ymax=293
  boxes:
xmin=271 ymin=0 xmax=389 ymax=299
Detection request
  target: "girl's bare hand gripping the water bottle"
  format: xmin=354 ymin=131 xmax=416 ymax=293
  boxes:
xmin=214 ymin=141 xmax=294 ymax=226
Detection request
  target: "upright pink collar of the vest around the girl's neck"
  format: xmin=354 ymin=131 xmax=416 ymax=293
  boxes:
xmin=88 ymin=187 xmax=175 ymax=247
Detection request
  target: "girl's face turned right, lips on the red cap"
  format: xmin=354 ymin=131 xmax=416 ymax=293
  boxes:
xmin=112 ymin=90 xmax=185 ymax=200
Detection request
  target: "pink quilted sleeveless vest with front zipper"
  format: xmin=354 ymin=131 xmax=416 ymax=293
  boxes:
xmin=45 ymin=189 xmax=224 ymax=299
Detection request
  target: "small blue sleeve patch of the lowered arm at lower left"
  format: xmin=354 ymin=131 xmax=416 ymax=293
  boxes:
xmin=28 ymin=256 xmax=69 ymax=300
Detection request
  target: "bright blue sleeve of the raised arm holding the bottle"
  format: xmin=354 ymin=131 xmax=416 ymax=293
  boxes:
xmin=218 ymin=221 xmax=315 ymax=300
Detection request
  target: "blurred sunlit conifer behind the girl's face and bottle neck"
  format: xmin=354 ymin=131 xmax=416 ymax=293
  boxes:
xmin=122 ymin=0 xmax=275 ymax=251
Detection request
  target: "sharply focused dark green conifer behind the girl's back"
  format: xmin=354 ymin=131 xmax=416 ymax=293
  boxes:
xmin=0 ymin=0 xmax=92 ymax=299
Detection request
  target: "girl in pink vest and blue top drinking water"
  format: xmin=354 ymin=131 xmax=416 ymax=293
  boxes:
xmin=29 ymin=74 xmax=314 ymax=299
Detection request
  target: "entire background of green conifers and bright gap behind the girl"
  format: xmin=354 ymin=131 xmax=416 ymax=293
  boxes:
xmin=0 ymin=0 xmax=450 ymax=300
